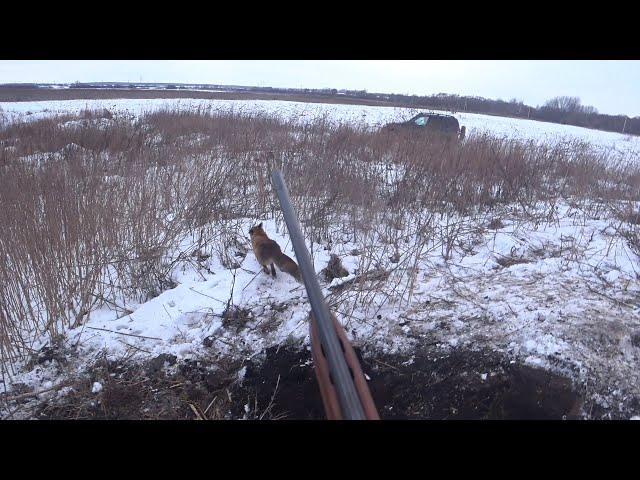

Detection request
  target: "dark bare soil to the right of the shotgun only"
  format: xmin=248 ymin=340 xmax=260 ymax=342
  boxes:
xmin=365 ymin=350 xmax=581 ymax=420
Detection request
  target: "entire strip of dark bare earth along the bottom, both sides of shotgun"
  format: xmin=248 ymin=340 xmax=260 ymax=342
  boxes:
xmin=28 ymin=346 xmax=582 ymax=420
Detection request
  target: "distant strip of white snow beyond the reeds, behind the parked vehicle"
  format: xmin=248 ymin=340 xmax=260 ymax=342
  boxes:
xmin=0 ymin=99 xmax=640 ymax=161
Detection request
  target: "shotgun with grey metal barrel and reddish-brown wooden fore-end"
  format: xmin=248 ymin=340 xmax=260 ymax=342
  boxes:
xmin=271 ymin=170 xmax=378 ymax=420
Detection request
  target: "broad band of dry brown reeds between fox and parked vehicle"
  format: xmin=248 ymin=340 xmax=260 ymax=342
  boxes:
xmin=0 ymin=109 xmax=640 ymax=372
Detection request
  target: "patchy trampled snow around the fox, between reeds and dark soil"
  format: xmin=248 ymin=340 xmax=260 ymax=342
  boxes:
xmin=5 ymin=205 xmax=640 ymax=415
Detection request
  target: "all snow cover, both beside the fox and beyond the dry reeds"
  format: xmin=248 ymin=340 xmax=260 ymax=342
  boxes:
xmin=0 ymin=99 xmax=640 ymax=418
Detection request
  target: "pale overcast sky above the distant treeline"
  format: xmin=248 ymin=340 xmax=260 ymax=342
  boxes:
xmin=0 ymin=60 xmax=640 ymax=116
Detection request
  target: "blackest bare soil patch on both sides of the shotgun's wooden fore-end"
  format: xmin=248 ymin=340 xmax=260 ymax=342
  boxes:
xmin=231 ymin=347 xmax=581 ymax=419
